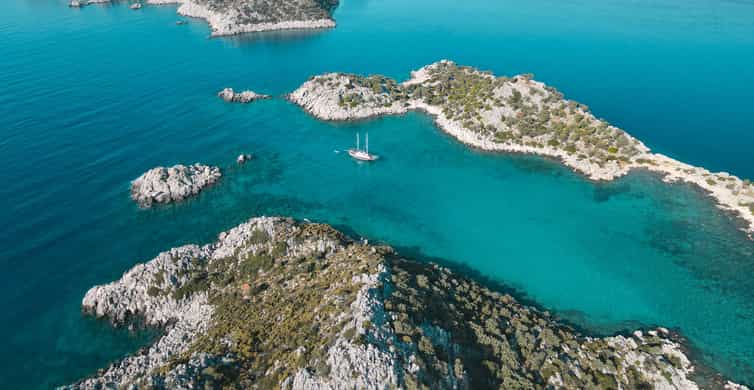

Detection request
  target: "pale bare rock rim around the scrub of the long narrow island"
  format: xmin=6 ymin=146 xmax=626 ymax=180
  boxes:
xmin=288 ymin=60 xmax=754 ymax=238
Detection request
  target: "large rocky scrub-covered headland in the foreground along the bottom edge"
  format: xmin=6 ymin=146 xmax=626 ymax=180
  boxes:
xmin=66 ymin=217 xmax=743 ymax=389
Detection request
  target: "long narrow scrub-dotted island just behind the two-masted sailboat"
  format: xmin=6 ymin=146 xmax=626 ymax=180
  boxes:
xmin=289 ymin=60 xmax=754 ymax=233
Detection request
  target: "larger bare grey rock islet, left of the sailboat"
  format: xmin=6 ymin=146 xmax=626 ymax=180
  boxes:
xmin=131 ymin=164 xmax=222 ymax=207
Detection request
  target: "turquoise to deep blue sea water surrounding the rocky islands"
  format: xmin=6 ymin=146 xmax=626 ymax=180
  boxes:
xmin=0 ymin=0 xmax=754 ymax=389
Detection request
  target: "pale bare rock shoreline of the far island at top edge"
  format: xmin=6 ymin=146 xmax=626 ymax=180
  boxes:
xmin=72 ymin=0 xmax=335 ymax=37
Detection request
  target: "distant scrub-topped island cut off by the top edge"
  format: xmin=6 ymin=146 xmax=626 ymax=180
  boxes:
xmin=71 ymin=0 xmax=338 ymax=36
